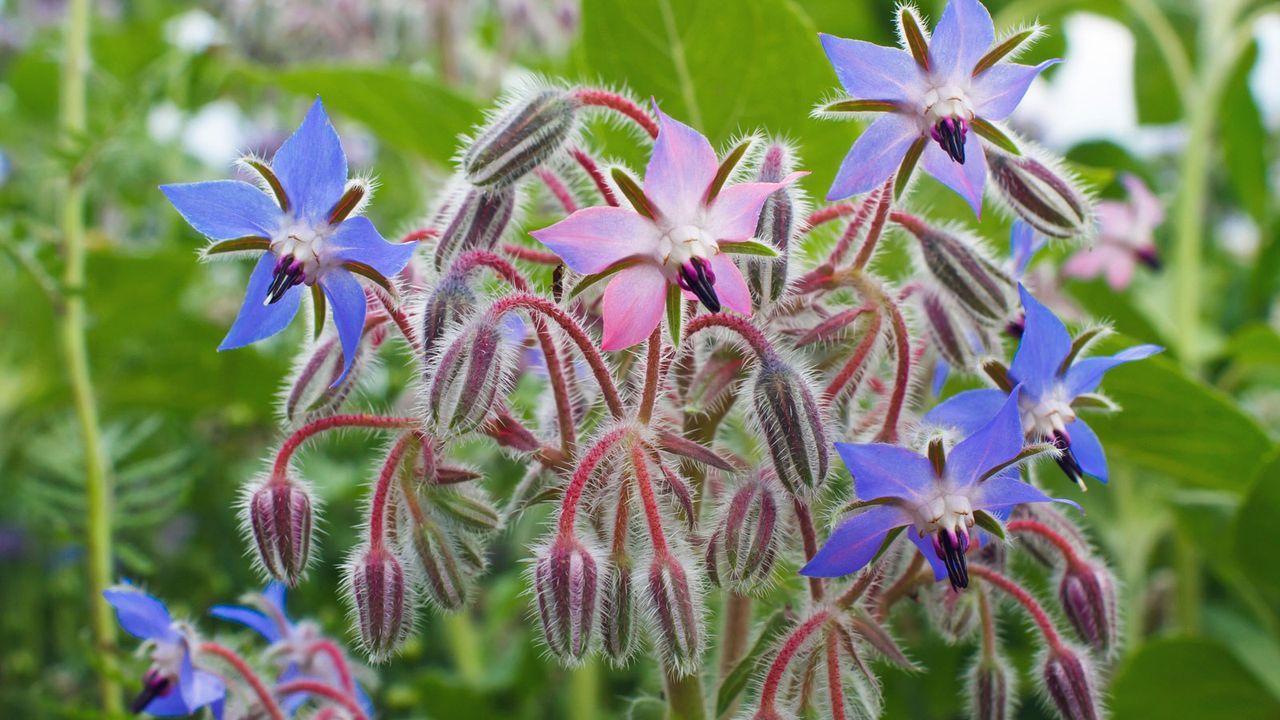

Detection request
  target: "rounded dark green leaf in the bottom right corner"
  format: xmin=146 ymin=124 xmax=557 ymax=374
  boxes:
xmin=1111 ymin=638 xmax=1280 ymax=720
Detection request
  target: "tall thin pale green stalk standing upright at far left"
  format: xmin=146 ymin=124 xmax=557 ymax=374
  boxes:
xmin=59 ymin=0 xmax=123 ymax=715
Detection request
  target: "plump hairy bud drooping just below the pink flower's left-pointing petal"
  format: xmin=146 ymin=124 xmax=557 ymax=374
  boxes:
xmin=424 ymin=314 xmax=511 ymax=434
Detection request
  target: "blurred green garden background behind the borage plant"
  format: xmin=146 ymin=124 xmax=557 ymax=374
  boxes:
xmin=0 ymin=0 xmax=1280 ymax=719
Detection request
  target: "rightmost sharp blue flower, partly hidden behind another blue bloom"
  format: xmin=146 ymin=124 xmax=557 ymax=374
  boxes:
xmin=924 ymin=284 xmax=1164 ymax=489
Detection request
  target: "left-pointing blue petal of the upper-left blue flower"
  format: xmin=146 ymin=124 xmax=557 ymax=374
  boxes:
xmin=160 ymin=181 xmax=280 ymax=240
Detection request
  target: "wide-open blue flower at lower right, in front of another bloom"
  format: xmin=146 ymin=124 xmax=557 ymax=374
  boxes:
xmin=800 ymin=389 xmax=1075 ymax=589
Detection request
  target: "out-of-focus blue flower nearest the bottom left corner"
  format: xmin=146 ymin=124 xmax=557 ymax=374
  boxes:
xmin=102 ymin=587 xmax=227 ymax=717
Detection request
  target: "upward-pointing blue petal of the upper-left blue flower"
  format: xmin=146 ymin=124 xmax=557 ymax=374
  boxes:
xmin=271 ymin=97 xmax=347 ymax=222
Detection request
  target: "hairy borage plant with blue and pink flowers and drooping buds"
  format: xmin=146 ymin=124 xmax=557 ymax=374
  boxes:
xmin=147 ymin=0 xmax=1156 ymax=719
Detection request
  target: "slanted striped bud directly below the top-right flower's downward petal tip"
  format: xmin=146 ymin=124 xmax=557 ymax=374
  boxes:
xmin=900 ymin=211 xmax=1014 ymax=325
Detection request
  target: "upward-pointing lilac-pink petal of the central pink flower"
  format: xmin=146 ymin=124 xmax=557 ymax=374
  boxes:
xmin=644 ymin=105 xmax=719 ymax=224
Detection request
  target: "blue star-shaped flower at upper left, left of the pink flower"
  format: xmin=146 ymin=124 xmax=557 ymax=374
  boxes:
xmin=160 ymin=99 xmax=415 ymax=386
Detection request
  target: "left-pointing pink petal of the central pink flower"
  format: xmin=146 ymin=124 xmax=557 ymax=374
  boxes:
xmin=529 ymin=208 xmax=658 ymax=273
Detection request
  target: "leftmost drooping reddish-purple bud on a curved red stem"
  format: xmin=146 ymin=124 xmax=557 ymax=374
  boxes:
xmin=244 ymin=478 xmax=314 ymax=587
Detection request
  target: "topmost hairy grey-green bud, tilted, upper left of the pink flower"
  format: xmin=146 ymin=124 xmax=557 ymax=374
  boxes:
xmin=462 ymin=88 xmax=576 ymax=188
